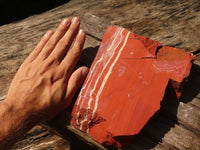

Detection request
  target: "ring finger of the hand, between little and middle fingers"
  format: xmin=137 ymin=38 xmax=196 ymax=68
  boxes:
xmin=39 ymin=19 xmax=71 ymax=60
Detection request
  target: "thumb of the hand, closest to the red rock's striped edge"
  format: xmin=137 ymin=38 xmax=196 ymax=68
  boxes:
xmin=65 ymin=67 xmax=89 ymax=107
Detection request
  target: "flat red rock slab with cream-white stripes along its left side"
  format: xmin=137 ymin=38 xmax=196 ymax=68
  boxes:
xmin=71 ymin=26 xmax=193 ymax=147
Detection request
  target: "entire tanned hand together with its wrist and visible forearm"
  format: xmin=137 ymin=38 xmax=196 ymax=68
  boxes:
xmin=0 ymin=17 xmax=88 ymax=150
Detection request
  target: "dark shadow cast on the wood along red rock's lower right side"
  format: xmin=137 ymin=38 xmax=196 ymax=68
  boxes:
xmin=123 ymin=64 xmax=200 ymax=150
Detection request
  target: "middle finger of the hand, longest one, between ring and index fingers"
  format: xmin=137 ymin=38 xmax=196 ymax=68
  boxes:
xmin=49 ymin=17 xmax=80 ymax=61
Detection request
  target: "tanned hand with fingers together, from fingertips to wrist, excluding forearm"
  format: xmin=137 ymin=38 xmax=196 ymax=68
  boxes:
xmin=5 ymin=18 xmax=88 ymax=120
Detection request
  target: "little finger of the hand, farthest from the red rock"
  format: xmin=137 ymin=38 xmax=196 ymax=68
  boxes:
xmin=27 ymin=30 xmax=54 ymax=62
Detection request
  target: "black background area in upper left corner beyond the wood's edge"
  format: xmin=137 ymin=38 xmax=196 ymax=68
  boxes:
xmin=0 ymin=0 xmax=69 ymax=25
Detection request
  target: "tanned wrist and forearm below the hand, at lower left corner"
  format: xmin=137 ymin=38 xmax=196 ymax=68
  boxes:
xmin=0 ymin=100 xmax=34 ymax=150
